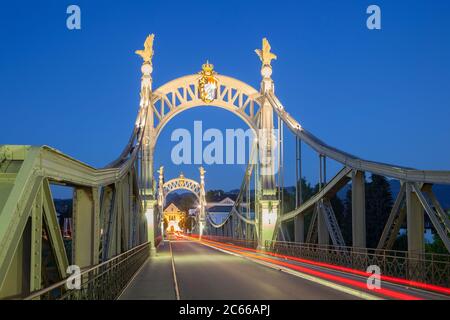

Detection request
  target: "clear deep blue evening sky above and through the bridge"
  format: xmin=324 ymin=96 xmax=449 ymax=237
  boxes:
xmin=0 ymin=0 xmax=450 ymax=195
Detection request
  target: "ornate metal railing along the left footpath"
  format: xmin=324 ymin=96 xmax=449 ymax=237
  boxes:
xmin=25 ymin=242 xmax=150 ymax=300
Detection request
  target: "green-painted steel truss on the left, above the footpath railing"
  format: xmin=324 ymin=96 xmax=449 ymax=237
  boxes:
xmin=0 ymin=146 xmax=146 ymax=297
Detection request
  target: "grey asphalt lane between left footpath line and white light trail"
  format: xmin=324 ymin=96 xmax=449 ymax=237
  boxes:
xmin=171 ymin=241 xmax=357 ymax=300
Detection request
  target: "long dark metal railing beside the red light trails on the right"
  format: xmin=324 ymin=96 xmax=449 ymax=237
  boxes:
xmin=266 ymin=241 xmax=450 ymax=287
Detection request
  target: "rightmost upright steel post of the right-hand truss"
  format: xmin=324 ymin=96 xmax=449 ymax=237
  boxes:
xmin=406 ymin=182 xmax=425 ymax=258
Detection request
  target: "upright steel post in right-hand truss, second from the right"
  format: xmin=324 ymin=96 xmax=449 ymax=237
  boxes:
xmin=352 ymin=171 xmax=366 ymax=248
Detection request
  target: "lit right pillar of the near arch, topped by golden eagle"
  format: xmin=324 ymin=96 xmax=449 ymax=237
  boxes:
xmin=255 ymin=38 xmax=280 ymax=250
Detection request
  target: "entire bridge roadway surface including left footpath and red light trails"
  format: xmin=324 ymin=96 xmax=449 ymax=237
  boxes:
xmin=120 ymin=238 xmax=450 ymax=300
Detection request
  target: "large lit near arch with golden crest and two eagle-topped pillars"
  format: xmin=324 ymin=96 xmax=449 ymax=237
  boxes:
xmin=136 ymin=35 xmax=279 ymax=249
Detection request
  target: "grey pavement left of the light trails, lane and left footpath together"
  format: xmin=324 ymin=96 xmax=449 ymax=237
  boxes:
xmin=121 ymin=240 xmax=356 ymax=299
